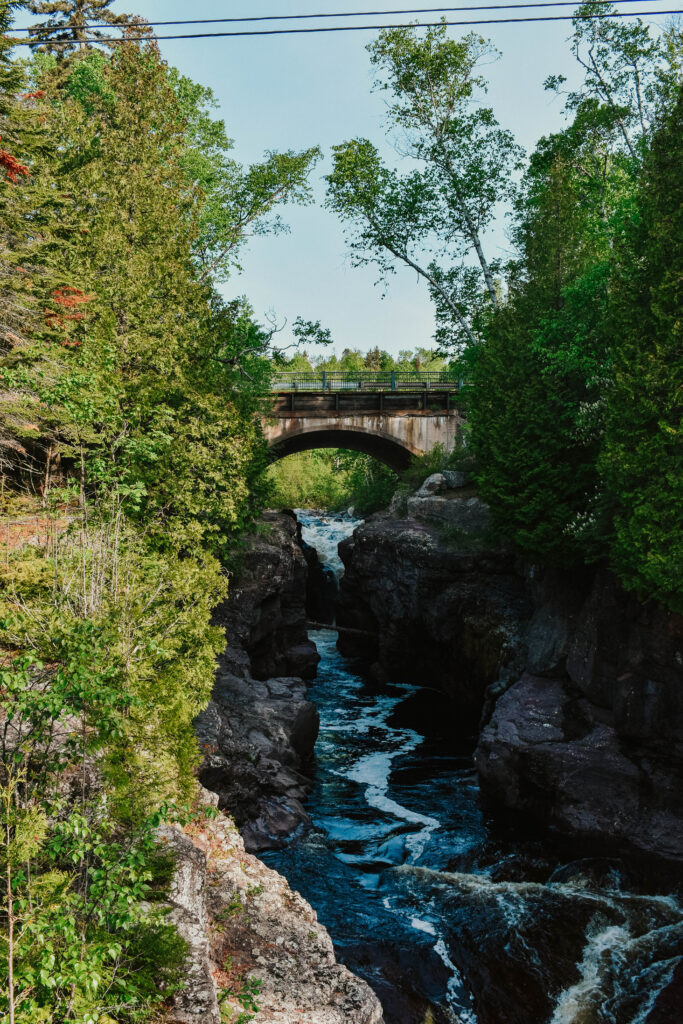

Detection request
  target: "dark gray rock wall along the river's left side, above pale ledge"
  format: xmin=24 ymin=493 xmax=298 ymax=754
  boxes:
xmin=196 ymin=512 xmax=319 ymax=851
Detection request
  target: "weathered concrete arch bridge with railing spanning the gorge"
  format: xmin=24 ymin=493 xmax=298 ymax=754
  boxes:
xmin=264 ymin=371 xmax=464 ymax=469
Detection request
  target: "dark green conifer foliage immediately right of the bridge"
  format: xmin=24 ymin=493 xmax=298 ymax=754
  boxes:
xmin=468 ymin=301 xmax=595 ymax=565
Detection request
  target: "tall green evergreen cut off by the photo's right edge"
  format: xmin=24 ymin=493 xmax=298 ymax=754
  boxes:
xmin=600 ymin=91 xmax=683 ymax=611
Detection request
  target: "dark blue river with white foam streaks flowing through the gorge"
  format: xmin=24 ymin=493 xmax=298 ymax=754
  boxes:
xmin=263 ymin=512 xmax=683 ymax=1024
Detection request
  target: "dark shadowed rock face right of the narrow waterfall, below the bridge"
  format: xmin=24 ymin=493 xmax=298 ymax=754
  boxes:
xmin=337 ymin=516 xmax=530 ymax=733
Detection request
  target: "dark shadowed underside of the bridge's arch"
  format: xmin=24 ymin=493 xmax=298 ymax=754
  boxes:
xmin=268 ymin=425 xmax=422 ymax=470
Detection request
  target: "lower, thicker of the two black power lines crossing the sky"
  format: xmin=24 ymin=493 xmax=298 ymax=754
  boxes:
xmin=9 ymin=8 xmax=683 ymax=46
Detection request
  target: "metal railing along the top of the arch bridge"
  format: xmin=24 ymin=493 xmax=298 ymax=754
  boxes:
xmin=270 ymin=370 xmax=462 ymax=391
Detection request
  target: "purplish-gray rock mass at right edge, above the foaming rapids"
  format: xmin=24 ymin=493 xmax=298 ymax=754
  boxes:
xmin=475 ymin=572 xmax=683 ymax=859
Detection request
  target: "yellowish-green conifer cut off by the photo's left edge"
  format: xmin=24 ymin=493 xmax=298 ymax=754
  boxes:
xmin=0 ymin=0 xmax=69 ymax=490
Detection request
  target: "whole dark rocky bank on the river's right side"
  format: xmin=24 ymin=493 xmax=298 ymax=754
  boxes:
xmin=338 ymin=476 xmax=683 ymax=861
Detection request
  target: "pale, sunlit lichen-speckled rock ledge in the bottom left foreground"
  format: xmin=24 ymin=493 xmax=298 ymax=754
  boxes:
xmin=160 ymin=794 xmax=382 ymax=1024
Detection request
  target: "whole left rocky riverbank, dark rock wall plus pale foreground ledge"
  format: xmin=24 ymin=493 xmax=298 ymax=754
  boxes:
xmin=176 ymin=512 xmax=382 ymax=1024
